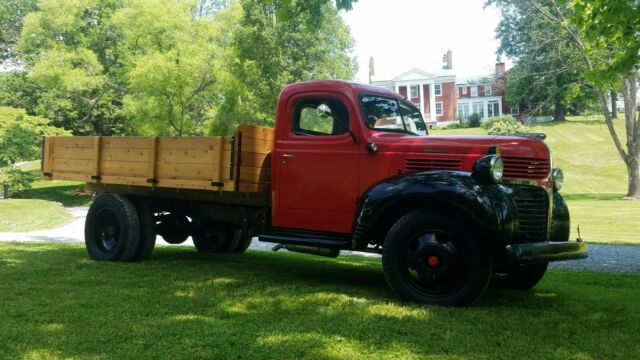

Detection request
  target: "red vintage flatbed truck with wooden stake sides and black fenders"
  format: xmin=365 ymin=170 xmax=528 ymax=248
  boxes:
xmin=42 ymin=81 xmax=587 ymax=305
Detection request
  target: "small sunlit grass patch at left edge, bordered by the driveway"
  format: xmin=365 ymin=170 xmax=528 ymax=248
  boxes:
xmin=0 ymin=199 xmax=73 ymax=232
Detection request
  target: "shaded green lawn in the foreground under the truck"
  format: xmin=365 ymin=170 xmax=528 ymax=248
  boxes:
xmin=0 ymin=243 xmax=640 ymax=359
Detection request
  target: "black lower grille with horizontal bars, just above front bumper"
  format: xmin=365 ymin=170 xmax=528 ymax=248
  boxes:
xmin=513 ymin=186 xmax=549 ymax=242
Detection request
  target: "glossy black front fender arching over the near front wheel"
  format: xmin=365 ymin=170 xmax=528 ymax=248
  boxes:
xmin=352 ymin=171 xmax=513 ymax=248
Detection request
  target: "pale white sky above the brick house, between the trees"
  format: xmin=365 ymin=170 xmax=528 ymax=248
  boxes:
xmin=342 ymin=0 xmax=509 ymax=82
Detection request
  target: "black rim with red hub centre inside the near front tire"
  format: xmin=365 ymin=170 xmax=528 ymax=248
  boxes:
xmin=402 ymin=230 xmax=470 ymax=296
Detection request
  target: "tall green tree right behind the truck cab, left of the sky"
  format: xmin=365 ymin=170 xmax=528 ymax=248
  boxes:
xmin=213 ymin=0 xmax=356 ymax=132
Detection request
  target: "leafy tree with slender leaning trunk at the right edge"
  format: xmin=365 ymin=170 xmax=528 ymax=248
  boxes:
xmin=495 ymin=0 xmax=640 ymax=199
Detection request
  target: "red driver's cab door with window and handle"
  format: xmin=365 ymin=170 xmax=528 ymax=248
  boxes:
xmin=272 ymin=92 xmax=358 ymax=233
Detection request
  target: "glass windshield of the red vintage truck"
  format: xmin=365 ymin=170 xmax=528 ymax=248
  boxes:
xmin=360 ymin=95 xmax=427 ymax=135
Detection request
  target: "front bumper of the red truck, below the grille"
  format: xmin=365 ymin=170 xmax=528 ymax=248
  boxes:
xmin=505 ymin=241 xmax=589 ymax=264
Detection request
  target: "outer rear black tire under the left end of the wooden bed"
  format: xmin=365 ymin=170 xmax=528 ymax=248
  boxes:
xmin=84 ymin=193 xmax=140 ymax=261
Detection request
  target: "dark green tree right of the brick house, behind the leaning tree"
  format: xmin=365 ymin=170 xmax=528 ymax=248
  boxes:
xmin=488 ymin=1 xmax=593 ymax=120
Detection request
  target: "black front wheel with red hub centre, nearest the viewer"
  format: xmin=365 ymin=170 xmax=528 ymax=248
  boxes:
xmin=382 ymin=210 xmax=493 ymax=306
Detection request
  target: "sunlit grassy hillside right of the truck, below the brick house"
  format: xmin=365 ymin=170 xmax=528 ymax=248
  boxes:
xmin=432 ymin=115 xmax=640 ymax=244
